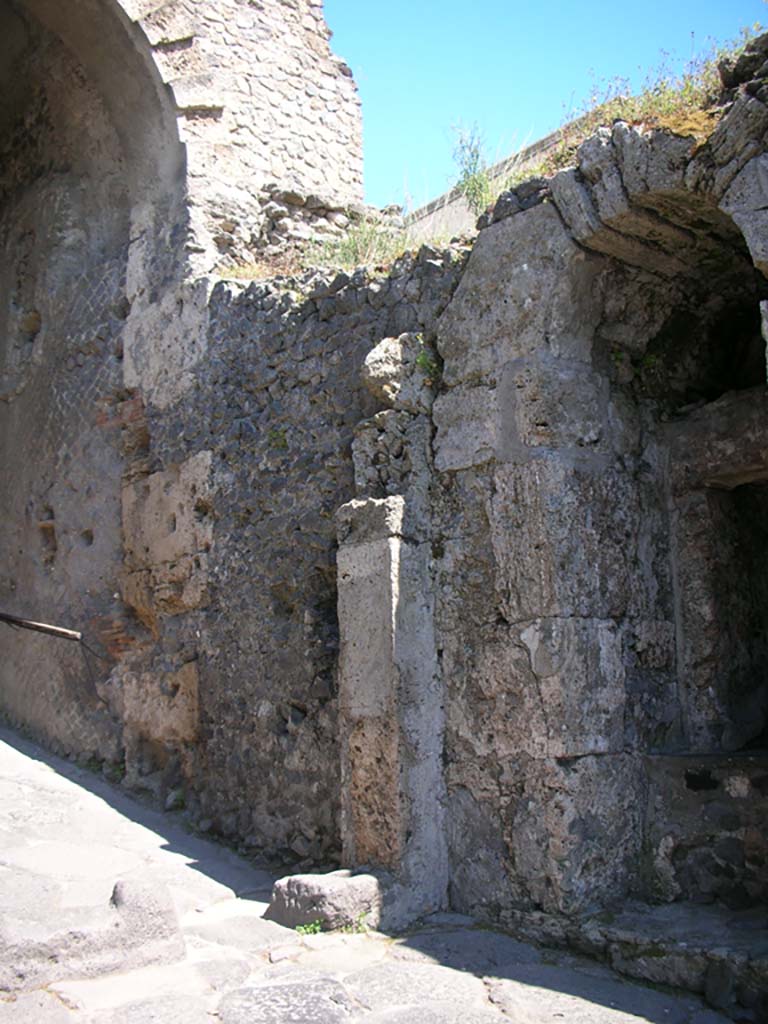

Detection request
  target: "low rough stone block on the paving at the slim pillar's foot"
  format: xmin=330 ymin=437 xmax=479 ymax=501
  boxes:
xmin=264 ymin=870 xmax=385 ymax=931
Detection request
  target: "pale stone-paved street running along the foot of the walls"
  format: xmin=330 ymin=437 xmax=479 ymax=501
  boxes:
xmin=0 ymin=730 xmax=726 ymax=1024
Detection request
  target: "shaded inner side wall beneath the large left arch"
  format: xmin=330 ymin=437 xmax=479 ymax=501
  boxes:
xmin=0 ymin=5 xmax=135 ymax=757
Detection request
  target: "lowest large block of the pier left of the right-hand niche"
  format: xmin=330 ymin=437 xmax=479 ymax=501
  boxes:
xmin=505 ymin=754 xmax=644 ymax=913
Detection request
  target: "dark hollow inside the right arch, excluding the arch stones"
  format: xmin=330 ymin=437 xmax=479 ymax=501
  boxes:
xmin=622 ymin=197 xmax=768 ymax=754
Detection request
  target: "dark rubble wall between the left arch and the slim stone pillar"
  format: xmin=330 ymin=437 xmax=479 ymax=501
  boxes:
xmin=109 ymin=249 xmax=468 ymax=861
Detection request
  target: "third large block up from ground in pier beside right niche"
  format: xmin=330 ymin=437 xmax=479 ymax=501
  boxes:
xmin=487 ymin=458 xmax=640 ymax=623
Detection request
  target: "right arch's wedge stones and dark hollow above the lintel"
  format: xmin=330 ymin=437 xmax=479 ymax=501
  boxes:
xmin=552 ymin=117 xmax=768 ymax=406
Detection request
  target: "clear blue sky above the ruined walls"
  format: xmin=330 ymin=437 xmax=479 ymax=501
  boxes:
xmin=325 ymin=0 xmax=768 ymax=208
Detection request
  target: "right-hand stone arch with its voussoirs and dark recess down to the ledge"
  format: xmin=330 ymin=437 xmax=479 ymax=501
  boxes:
xmin=552 ymin=117 xmax=768 ymax=753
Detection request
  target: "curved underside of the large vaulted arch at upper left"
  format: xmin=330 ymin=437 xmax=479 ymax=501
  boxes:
xmin=3 ymin=0 xmax=185 ymax=288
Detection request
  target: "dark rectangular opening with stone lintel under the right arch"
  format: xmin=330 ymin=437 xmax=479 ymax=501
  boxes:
xmin=665 ymin=388 xmax=766 ymax=751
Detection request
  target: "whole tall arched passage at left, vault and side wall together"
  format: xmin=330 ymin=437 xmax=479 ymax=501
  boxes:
xmin=0 ymin=0 xmax=184 ymax=757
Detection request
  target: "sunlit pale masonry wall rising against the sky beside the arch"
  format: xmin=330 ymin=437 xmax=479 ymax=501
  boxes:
xmin=124 ymin=0 xmax=362 ymax=267
